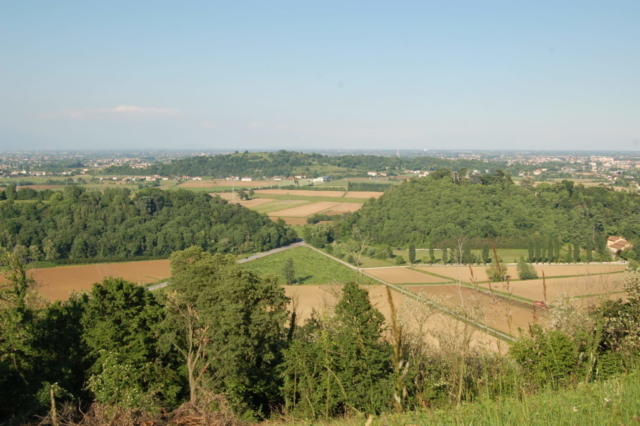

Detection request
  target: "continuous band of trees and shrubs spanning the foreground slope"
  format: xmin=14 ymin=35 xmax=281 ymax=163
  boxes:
xmin=0 ymin=247 xmax=640 ymax=426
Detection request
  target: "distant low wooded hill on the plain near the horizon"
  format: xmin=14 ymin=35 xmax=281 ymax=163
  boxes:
xmin=104 ymin=151 xmax=506 ymax=178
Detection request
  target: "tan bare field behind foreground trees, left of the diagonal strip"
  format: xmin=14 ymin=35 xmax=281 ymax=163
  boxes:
xmin=284 ymin=284 xmax=506 ymax=351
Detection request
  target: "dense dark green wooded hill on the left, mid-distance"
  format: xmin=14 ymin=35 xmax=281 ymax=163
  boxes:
xmin=0 ymin=186 xmax=296 ymax=261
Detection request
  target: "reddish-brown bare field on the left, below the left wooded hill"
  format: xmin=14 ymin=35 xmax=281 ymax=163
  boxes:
xmin=34 ymin=259 xmax=171 ymax=300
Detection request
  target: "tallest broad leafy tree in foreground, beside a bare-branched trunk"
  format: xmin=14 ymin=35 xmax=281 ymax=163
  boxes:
xmin=165 ymin=247 xmax=288 ymax=414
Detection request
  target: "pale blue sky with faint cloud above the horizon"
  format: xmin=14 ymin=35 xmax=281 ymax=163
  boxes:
xmin=0 ymin=0 xmax=640 ymax=150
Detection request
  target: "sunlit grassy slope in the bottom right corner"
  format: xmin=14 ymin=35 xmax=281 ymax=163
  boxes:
xmin=283 ymin=372 xmax=640 ymax=426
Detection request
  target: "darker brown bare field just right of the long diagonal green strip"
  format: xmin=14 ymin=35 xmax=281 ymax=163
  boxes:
xmin=405 ymin=285 xmax=547 ymax=336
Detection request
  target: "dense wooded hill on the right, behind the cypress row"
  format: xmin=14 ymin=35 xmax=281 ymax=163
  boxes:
xmin=350 ymin=169 xmax=640 ymax=250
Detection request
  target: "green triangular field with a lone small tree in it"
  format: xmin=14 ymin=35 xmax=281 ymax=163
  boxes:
xmin=243 ymin=247 xmax=377 ymax=285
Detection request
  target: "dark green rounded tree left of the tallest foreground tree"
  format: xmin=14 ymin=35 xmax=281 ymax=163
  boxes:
xmin=82 ymin=278 xmax=180 ymax=409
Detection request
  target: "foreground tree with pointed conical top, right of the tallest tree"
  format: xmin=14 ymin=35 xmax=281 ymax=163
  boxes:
xmin=283 ymin=283 xmax=392 ymax=418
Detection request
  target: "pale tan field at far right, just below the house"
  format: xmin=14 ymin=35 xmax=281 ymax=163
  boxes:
xmin=480 ymin=274 xmax=624 ymax=302
